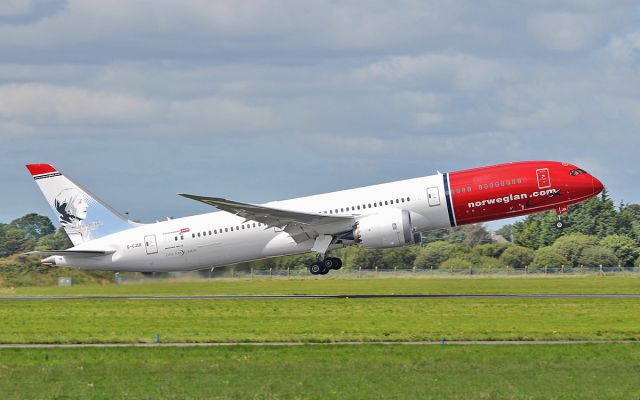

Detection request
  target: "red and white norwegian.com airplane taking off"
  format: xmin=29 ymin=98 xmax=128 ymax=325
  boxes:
xmin=27 ymin=161 xmax=604 ymax=275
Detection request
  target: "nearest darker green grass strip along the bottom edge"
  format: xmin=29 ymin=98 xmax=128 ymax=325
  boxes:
xmin=0 ymin=344 xmax=640 ymax=400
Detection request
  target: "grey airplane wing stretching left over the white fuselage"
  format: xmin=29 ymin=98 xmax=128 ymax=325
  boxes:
xmin=179 ymin=193 xmax=355 ymax=243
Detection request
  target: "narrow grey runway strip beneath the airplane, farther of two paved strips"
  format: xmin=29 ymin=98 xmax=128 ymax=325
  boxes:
xmin=0 ymin=293 xmax=640 ymax=301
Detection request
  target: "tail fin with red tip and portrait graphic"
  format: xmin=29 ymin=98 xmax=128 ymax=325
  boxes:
xmin=27 ymin=164 xmax=135 ymax=246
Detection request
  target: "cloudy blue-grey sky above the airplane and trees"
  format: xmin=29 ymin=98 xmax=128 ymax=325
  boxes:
xmin=0 ymin=0 xmax=640 ymax=230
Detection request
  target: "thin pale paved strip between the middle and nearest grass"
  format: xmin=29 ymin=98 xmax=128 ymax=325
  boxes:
xmin=0 ymin=340 xmax=640 ymax=350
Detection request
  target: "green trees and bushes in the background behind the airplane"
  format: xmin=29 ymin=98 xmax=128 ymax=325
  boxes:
xmin=0 ymin=191 xmax=640 ymax=286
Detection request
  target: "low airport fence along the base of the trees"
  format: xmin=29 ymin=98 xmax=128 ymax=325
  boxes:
xmin=116 ymin=265 xmax=640 ymax=283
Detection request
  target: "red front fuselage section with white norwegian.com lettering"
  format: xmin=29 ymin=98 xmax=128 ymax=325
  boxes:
xmin=449 ymin=161 xmax=594 ymax=225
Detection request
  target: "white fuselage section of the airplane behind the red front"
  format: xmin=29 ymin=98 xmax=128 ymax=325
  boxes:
xmin=56 ymin=174 xmax=451 ymax=271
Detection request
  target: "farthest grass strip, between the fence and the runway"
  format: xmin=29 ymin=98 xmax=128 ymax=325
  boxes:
xmin=5 ymin=275 xmax=640 ymax=296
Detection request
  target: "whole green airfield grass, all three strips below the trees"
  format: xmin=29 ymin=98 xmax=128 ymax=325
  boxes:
xmin=0 ymin=276 xmax=640 ymax=399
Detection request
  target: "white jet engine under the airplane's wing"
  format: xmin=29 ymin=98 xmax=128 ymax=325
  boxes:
xmin=353 ymin=209 xmax=422 ymax=249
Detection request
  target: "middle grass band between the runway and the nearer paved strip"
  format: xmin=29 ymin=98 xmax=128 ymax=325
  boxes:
xmin=0 ymin=298 xmax=640 ymax=343
